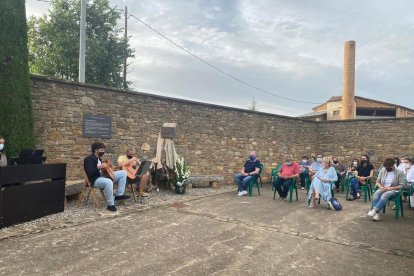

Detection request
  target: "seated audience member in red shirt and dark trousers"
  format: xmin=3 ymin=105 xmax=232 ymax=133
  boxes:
xmin=273 ymin=155 xmax=300 ymax=201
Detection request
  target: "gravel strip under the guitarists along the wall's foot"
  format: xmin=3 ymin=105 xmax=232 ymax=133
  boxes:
xmin=0 ymin=185 xmax=236 ymax=240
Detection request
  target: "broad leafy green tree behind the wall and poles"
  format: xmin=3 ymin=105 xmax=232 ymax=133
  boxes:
xmin=28 ymin=0 xmax=133 ymax=88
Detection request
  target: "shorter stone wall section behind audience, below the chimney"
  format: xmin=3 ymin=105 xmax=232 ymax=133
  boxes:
xmin=317 ymin=118 xmax=414 ymax=168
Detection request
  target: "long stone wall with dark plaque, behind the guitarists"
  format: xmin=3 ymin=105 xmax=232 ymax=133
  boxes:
xmin=32 ymin=77 xmax=316 ymax=183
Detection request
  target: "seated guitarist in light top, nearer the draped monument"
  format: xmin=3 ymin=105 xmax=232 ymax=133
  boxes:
xmin=118 ymin=147 xmax=149 ymax=197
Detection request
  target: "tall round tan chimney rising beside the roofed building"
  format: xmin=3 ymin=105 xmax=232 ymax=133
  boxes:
xmin=341 ymin=41 xmax=356 ymax=120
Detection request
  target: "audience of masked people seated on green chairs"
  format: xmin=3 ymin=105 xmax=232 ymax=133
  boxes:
xmin=235 ymin=152 xmax=414 ymax=220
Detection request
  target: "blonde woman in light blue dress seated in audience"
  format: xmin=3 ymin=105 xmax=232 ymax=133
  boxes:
xmin=308 ymin=157 xmax=338 ymax=210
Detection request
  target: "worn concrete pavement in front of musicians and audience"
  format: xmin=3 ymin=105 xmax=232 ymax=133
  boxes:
xmin=0 ymin=186 xmax=414 ymax=275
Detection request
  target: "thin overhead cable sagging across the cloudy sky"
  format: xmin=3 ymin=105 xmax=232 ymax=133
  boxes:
xmin=129 ymin=13 xmax=321 ymax=104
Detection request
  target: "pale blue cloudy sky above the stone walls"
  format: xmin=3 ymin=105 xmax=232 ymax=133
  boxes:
xmin=26 ymin=0 xmax=414 ymax=116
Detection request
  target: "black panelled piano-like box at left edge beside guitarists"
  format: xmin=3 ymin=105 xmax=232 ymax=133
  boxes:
xmin=0 ymin=164 xmax=66 ymax=228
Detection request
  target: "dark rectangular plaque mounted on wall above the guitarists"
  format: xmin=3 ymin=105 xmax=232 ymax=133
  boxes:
xmin=83 ymin=114 xmax=112 ymax=139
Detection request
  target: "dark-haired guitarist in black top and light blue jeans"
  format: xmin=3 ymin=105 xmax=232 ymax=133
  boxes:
xmin=83 ymin=142 xmax=129 ymax=212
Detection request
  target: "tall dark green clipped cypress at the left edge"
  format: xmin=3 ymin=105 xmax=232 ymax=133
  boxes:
xmin=0 ymin=0 xmax=35 ymax=156
